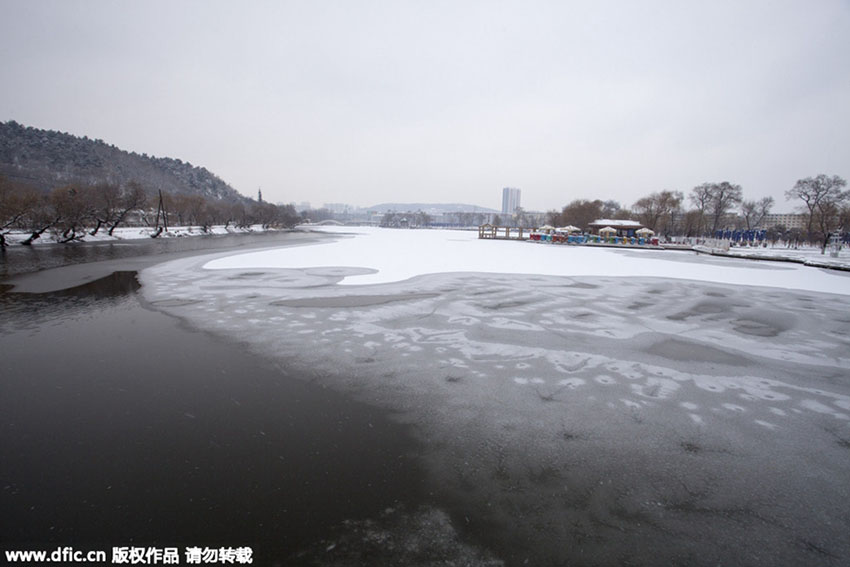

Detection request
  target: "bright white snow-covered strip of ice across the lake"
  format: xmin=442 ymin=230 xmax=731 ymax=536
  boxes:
xmin=204 ymin=227 xmax=850 ymax=293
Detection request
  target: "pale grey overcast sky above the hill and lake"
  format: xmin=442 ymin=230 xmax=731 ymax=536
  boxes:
xmin=0 ymin=0 xmax=850 ymax=212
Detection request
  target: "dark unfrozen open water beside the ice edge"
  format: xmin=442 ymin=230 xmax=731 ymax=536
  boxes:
xmin=0 ymin=237 xmax=425 ymax=565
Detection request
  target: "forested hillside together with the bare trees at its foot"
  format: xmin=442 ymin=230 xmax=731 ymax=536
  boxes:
xmin=0 ymin=121 xmax=299 ymax=244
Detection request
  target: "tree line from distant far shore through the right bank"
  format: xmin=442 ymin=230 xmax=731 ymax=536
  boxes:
xmin=314 ymin=175 xmax=850 ymax=251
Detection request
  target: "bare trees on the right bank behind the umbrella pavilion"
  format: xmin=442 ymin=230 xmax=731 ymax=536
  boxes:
xmin=547 ymin=174 xmax=850 ymax=246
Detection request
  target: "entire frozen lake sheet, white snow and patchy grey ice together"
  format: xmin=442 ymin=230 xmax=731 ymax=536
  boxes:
xmin=142 ymin=229 xmax=850 ymax=565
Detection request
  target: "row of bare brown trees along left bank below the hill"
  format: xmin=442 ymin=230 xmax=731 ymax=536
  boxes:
xmin=0 ymin=176 xmax=299 ymax=246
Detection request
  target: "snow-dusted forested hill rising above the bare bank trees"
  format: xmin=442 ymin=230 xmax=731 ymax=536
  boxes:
xmin=0 ymin=121 xmax=248 ymax=202
